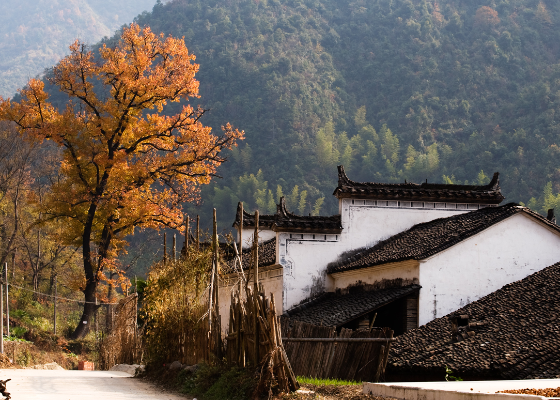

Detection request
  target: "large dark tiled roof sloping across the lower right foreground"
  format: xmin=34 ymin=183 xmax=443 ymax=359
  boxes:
xmin=388 ymin=263 xmax=560 ymax=379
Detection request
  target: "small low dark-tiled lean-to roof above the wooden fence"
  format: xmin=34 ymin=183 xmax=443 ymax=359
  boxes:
xmin=284 ymin=285 xmax=421 ymax=327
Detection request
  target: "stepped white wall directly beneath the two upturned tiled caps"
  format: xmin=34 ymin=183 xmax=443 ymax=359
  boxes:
xmin=280 ymin=199 xmax=490 ymax=310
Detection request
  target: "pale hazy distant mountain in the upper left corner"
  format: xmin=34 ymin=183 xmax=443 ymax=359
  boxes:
xmin=0 ymin=0 xmax=164 ymax=97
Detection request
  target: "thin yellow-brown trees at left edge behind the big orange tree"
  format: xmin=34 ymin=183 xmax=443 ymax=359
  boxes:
xmin=0 ymin=122 xmax=82 ymax=299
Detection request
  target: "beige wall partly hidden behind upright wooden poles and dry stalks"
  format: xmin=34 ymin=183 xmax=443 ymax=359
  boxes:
xmin=218 ymin=265 xmax=284 ymax=334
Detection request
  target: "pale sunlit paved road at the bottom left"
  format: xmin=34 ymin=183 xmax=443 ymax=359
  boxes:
xmin=0 ymin=369 xmax=188 ymax=400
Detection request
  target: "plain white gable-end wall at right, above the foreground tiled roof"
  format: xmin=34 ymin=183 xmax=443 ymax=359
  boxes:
xmin=418 ymin=214 xmax=560 ymax=326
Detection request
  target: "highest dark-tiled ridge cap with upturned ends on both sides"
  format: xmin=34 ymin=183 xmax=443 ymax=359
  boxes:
xmin=333 ymin=165 xmax=504 ymax=204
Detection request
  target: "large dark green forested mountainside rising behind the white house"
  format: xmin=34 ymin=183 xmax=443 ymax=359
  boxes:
xmin=44 ymin=0 xmax=560 ymax=225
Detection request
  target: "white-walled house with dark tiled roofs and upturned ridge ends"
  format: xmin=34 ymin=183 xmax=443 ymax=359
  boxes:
xmin=221 ymin=167 xmax=560 ymax=333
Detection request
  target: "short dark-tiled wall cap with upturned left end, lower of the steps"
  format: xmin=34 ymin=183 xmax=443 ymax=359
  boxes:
xmin=272 ymin=197 xmax=342 ymax=233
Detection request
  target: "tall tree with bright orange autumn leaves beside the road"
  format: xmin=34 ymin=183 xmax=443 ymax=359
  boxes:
xmin=0 ymin=24 xmax=243 ymax=338
